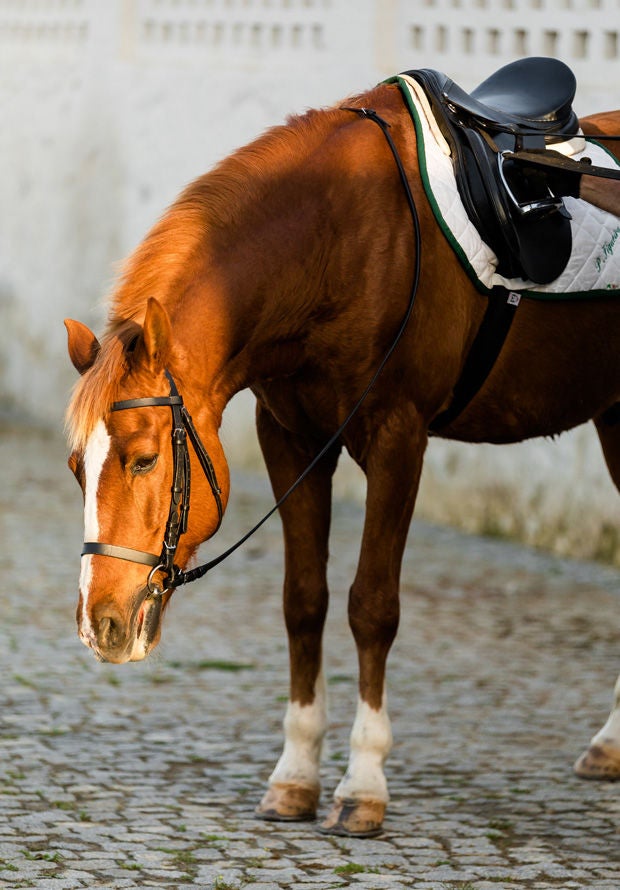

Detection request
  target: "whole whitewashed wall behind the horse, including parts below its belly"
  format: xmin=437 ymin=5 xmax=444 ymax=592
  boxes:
xmin=0 ymin=0 xmax=620 ymax=558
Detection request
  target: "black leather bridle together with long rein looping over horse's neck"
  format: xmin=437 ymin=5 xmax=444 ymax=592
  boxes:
xmin=82 ymin=106 xmax=422 ymax=598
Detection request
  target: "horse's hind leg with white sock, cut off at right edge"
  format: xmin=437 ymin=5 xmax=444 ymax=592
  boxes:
xmin=575 ymin=419 xmax=620 ymax=779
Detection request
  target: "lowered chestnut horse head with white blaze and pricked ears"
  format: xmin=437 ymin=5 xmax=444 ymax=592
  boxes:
xmin=65 ymin=299 xmax=229 ymax=663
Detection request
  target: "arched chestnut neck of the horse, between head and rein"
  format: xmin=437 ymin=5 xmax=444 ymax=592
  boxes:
xmin=139 ymin=88 xmax=402 ymax=418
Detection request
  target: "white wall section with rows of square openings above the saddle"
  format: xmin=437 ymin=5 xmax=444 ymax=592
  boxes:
xmin=382 ymin=0 xmax=620 ymax=114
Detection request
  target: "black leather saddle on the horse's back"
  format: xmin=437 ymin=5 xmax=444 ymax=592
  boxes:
xmin=405 ymin=57 xmax=579 ymax=284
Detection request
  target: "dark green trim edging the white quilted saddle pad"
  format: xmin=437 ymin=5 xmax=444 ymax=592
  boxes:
xmin=382 ymin=75 xmax=620 ymax=301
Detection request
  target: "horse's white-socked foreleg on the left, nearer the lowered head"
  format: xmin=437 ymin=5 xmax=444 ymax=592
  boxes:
xmin=256 ymin=403 xmax=339 ymax=821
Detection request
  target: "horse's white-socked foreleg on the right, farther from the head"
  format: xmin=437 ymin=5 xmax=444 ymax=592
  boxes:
xmin=321 ymin=418 xmax=426 ymax=837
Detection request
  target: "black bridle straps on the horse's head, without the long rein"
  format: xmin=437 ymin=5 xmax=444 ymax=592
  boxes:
xmin=82 ymin=371 xmax=224 ymax=596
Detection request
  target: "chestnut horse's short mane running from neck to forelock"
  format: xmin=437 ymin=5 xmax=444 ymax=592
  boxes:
xmin=66 ymin=98 xmax=366 ymax=450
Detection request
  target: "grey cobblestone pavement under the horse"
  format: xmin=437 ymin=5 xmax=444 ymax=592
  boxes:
xmin=0 ymin=429 xmax=620 ymax=890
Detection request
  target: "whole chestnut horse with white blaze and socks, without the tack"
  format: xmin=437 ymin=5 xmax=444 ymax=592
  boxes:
xmin=67 ymin=78 xmax=620 ymax=836
